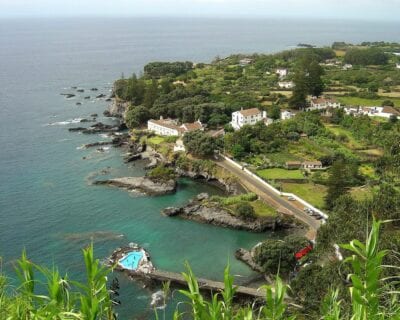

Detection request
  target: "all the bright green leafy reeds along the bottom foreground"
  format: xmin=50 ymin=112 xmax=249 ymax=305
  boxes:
xmin=0 ymin=221 xmax=400 ymax=320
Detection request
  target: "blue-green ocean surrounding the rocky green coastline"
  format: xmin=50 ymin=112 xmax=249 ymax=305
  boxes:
xmin=0 ymin=18 xmax=400 ymax=319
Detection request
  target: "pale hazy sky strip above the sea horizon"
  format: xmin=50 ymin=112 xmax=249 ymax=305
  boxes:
xmin=0 ymin=0 xmax=400 ymax=21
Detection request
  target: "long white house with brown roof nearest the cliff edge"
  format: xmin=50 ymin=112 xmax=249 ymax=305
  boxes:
xmin=147 ymin=117 xmax=204 ymax=136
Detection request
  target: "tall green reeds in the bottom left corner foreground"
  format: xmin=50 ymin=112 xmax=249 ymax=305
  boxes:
xmin=0 ymin=245 xmax=115 ymax=320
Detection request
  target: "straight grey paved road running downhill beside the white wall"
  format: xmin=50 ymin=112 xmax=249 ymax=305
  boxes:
xmin=216 ymin=160 xmax=321 ymax=238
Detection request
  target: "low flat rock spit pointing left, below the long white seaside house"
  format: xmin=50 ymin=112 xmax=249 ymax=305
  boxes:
xmin=93 ymin=177 xmax=177 ymax=196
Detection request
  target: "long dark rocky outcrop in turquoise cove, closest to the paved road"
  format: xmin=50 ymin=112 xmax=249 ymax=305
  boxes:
xmin=162 ymin=194 xmax=279 ymax=232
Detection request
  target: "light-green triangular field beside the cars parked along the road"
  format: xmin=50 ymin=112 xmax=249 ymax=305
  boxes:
xmin=282 ymin=182 xmax=326 ymax=209
